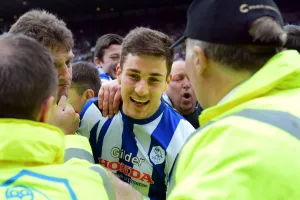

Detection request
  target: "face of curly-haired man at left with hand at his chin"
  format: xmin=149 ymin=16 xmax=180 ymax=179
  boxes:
xmin=52 ymin=50 xmax=74 ymax=101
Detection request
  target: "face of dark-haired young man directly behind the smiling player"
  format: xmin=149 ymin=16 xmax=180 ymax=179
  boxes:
xmin=102 ymin=44 xmax=121 ymax=79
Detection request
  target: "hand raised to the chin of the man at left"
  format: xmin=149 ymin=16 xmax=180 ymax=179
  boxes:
xmin=49 ymin=96 xmax=80 ymax=135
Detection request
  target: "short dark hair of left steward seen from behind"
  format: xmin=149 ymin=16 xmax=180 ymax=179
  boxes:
xmin=0 ymin=34 xmax=58 ymax=120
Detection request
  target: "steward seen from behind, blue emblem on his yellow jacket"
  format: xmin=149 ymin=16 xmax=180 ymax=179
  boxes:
xmin=0 ymin=34 xmax=115 ymax=200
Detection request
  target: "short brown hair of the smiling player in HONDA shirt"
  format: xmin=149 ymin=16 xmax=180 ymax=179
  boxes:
xmin=120 ymin=27 xmax=174 ymax=75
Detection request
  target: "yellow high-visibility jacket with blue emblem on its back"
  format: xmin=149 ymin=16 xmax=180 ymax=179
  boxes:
xmin=0 ymin=119 xmax=115 ymax=200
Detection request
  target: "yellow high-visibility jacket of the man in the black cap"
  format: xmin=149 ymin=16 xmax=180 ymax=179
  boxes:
xmin=168 ymin=50 xmax=300 ymax=200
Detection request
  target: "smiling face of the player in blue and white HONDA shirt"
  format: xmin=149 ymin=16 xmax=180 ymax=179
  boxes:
xmin=117 ymin=55 xmax=170 ymax=119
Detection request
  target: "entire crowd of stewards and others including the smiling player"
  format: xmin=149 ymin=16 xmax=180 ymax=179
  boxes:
xmin=0 ymin=0 xmax=300 ymax=200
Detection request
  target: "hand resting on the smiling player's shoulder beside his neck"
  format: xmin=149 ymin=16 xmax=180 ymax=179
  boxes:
xmin=98 ymin=80 xmax=122 ymax=118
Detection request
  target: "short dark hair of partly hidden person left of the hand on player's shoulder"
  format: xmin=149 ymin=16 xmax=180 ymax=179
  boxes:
xmin=71 ymin=61 xmax=101 ymax=97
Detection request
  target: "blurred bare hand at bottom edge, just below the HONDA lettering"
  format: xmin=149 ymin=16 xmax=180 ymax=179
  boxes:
xmin=107 ymin=170 xmax=143 ymax=200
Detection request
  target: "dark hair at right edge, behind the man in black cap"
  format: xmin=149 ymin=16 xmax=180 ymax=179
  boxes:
xmin=284 ymin=24 xmax=300 ymax=53
